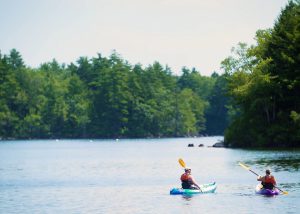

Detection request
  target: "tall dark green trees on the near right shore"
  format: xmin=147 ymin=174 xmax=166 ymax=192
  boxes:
xmin=222 ymin=1 xmax=300 ymax=147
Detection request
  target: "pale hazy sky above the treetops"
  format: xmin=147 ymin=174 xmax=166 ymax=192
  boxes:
xmin=0 ymin=0 xmax=288 ymax=76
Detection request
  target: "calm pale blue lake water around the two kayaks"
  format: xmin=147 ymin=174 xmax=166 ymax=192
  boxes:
xmin=0 ymin=137 xmax=300 ymax=214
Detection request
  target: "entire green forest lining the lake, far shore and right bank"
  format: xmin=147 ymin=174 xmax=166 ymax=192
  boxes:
xmin=0 ymin=0 xmax=300 ymax=147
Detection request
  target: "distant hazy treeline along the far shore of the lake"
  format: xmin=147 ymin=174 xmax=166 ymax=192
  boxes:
xmin=0 ymin=49 xmax=227 ymax=139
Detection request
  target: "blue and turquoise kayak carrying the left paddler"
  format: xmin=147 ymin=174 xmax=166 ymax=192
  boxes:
xmin=170 ymin=182 xmax=217 ymax=195
